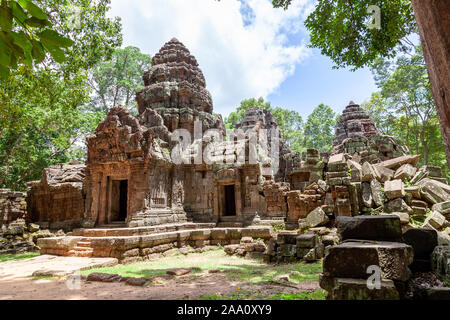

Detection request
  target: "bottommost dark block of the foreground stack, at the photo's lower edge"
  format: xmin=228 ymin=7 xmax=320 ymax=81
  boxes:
xmin=320 ymin=277 xmax=400 ymax=300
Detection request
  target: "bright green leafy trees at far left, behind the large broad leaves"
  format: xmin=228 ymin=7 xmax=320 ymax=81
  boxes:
xmin=0 ymin=0 xmax=122 ymax=190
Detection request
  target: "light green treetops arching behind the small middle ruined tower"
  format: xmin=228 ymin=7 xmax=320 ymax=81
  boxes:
xmin=225 ymin=98 xmax=305 ymax=152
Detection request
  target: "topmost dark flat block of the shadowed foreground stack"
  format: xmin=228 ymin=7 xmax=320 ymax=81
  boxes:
xmin=336 ymin=216 xmax=402 ymax=241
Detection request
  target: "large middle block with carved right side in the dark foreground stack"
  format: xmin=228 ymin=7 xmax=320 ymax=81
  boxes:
xmin=323 ymin=240 xmax=414 ymax=281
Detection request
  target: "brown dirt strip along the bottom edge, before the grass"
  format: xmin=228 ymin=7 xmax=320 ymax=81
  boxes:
xmin=0 ymin=274 xmax=320 ymax=300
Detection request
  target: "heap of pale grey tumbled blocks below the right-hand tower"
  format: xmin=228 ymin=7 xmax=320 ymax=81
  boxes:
xmin=298 ymin=154 xmax=450 ymax=245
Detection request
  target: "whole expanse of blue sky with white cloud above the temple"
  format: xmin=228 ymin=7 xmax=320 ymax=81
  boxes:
xmin=110 ymin=0 xmax=377 ymax=120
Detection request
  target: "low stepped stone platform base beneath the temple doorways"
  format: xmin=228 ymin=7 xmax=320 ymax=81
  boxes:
xmin=38 ymin=224 xmax=271 ymax=263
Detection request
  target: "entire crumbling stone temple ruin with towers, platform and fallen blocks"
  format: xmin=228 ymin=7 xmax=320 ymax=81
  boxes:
xmin=0 ymin=39 xmax=450 ymax=299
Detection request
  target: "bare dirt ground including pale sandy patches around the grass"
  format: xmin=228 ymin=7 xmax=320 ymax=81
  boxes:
xmin=0 ymin=252 xmax=320 ymax=300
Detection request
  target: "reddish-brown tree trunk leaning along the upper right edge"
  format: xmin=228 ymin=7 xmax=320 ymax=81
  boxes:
xmin=411 ymin=0 xmax=450 ymax=167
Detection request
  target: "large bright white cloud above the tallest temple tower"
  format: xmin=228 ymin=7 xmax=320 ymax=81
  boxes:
xmin=111 ymin=0 xmax=310 ymax=116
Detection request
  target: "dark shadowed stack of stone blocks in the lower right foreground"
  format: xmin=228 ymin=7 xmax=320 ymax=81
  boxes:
xmin=320 ymin=216 xmax=450 ymax=300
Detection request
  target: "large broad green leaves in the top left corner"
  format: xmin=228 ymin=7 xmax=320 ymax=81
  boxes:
xmin=0 ymin=0 xmax=74 ymax=79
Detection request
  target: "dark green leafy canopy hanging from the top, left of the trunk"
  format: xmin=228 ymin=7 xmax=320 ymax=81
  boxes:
xmin=272 ymin=0 xmax=416 ymax=69
